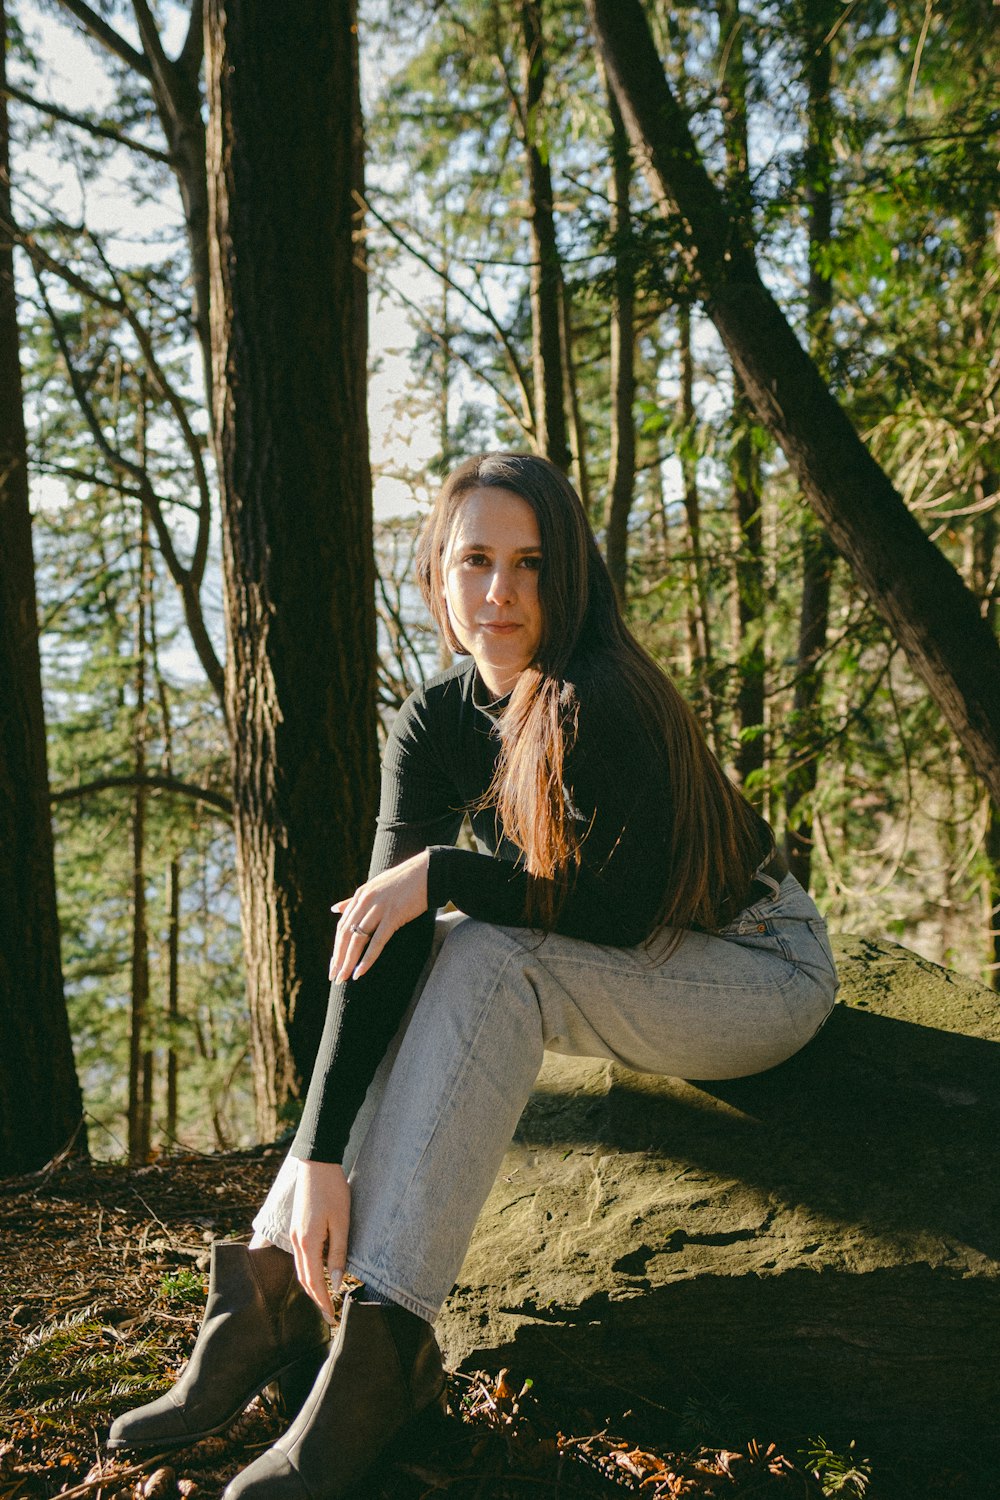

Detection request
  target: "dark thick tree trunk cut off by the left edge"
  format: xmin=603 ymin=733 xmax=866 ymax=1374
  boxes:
xmin=0 ymin=0 xmax=87 ymax=1176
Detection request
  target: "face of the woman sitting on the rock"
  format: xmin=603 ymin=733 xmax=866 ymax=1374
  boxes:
xmin=444 ymin=486 xmax=543 ymax=698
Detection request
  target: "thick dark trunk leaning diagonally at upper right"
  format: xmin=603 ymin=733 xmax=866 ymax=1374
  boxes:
xmin=586 ymin=0 xmax=1000 ymax=797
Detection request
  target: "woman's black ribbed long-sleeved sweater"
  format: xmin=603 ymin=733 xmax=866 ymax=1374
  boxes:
xmin=292 ymin=659 xmax=771 ymax=1161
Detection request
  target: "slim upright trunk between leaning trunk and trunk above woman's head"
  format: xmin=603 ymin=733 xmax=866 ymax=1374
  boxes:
xmin=604 ymin=69 xmax=636 ymax=605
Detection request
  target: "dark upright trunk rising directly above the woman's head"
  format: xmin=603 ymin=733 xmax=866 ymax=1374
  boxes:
xmin=520 ymin=0 xmax=573 ymax=474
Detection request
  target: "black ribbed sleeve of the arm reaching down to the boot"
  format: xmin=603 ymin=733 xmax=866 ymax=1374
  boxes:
xmin=292 ymin=695 xmax=463 ymax=1163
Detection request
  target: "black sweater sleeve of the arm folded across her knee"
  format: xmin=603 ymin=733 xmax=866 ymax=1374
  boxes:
xmin=429 ymin=692 xmax=673 ymax=948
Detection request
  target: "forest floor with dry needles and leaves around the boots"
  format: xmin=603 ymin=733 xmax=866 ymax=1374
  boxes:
xmin=0 ymin=1149 xmax=941 ymax=1500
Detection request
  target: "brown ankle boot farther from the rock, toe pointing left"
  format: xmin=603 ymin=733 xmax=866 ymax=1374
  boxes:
xmin=108 ymin=1241 xmax=330 ymax=1449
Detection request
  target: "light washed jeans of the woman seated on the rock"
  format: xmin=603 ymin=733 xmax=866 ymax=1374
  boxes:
xmin=253 ymin=876 xmax=837 ymax=1322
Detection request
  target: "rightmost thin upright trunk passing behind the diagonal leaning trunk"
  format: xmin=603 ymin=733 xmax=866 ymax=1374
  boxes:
xmin=784 ymin=0 xmax=837 ymax=891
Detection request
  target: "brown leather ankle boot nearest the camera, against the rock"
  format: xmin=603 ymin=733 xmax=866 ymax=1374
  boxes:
xmin=223 ymin=1293 xmax=445 ymax=1500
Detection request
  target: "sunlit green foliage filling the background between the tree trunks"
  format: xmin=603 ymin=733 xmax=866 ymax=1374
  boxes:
xmin=12 ymin=0 xmax=1000 ymax=1176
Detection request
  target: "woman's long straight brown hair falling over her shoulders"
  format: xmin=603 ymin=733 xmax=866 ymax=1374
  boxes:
xmin=417 ymin=453 xmax=766 ymax=930
